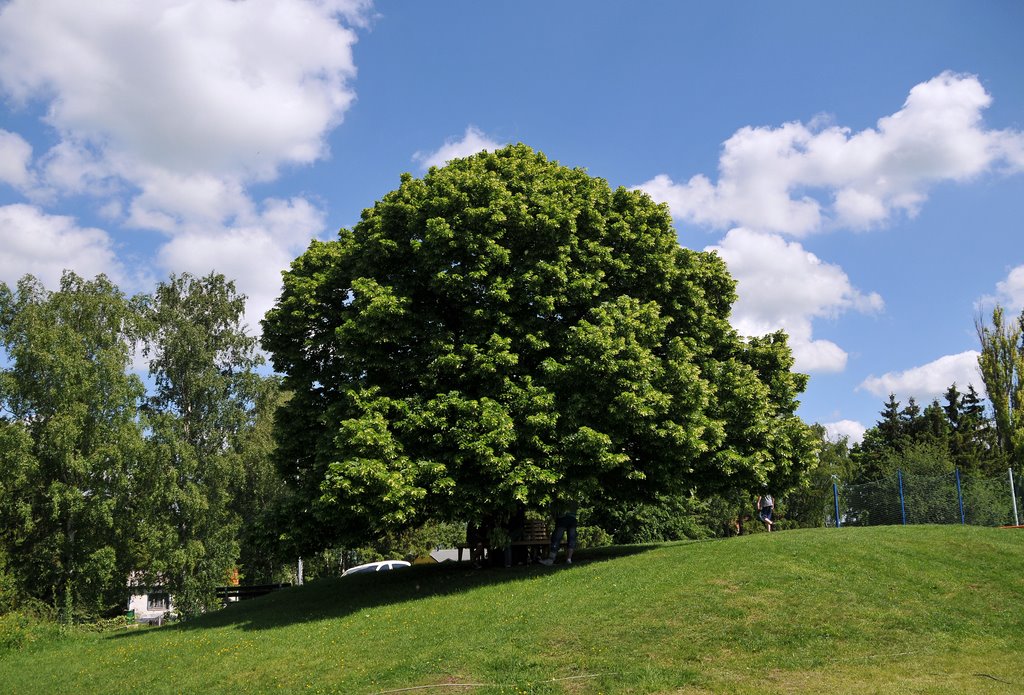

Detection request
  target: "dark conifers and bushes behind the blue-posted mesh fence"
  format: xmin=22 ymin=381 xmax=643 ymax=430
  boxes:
xmin=779 ymin=385 xmax=1024 ymax=528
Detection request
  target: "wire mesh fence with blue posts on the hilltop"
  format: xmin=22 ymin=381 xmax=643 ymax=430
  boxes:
xmin=826 ymin=470 xmax=1024 ymax=526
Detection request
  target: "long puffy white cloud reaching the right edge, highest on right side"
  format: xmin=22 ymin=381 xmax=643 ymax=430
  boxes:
xmin=639 ymin=73 xmax=1024 ymax=235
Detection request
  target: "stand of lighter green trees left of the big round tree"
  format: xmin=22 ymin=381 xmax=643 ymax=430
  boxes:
xmin=0 ymin=272 xmax=281 ymax=621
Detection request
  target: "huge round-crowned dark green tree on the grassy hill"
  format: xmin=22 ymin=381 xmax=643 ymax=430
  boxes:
xmin=263 ymin=145 xmax=815 ymax=542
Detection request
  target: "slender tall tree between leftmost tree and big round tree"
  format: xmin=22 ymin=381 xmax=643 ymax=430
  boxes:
xmin=133 ymin=274 xmax=276 ymax=615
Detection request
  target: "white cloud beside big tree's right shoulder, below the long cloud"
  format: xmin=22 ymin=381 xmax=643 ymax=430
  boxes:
xmin=707 ymin=228 xmax=883 ymax=373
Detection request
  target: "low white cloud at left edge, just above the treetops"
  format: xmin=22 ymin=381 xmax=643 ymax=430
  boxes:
xmin=0 ymin=205 xmax=125 ymax=290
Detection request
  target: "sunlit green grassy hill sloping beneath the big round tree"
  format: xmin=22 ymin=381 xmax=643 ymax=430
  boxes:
xmin=0 ymin=526 xmax=1024 ymax=695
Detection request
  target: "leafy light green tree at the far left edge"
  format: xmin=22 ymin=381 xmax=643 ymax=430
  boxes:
xmin=0 ymin=272 xmax=144 ymax=620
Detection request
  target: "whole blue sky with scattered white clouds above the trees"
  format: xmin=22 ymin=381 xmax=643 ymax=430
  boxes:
xmin=0 ymin=0 xmax=1024 ymax=439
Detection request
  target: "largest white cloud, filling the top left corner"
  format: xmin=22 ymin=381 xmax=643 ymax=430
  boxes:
xmin=0 ymin=0 xmax=364 ymax=185
